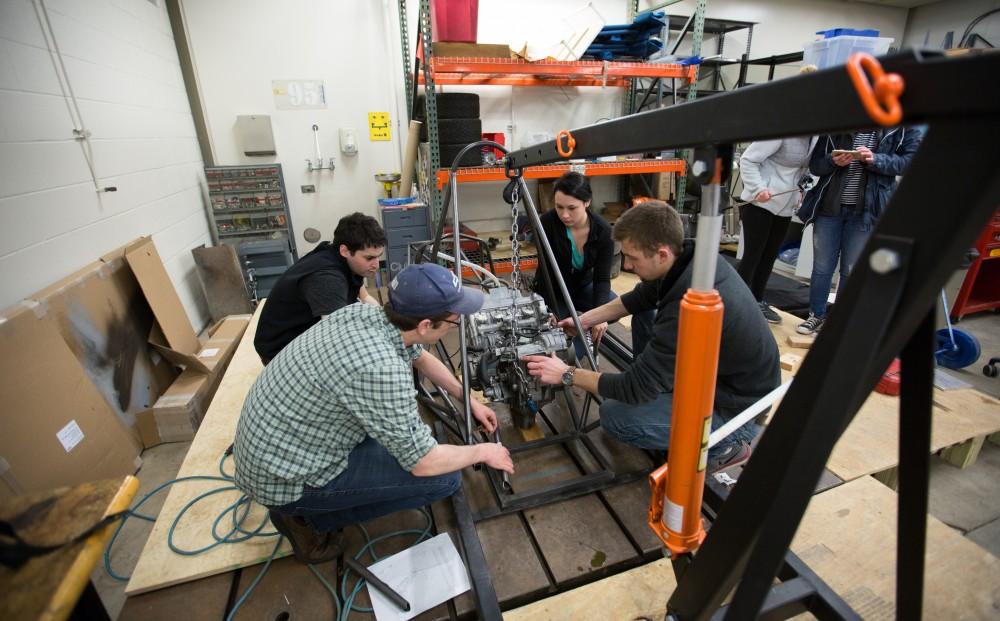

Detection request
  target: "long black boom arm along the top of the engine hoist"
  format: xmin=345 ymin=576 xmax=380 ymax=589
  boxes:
xmin=507 ymin=51 xmax=1000 ymax=169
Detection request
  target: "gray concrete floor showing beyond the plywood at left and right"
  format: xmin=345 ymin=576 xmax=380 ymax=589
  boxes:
xmin=93 ymin=273 xmax=1000 ymax=619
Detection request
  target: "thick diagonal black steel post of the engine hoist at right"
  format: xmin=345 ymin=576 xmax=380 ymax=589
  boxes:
xmin=670 ymin=118 xmax=1000 ymax=619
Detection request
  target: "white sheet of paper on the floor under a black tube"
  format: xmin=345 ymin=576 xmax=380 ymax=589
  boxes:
xmin=368 ymin=533 xmax=471 ymax=621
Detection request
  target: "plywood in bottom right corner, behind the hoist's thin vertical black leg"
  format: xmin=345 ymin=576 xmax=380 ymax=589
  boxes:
xmin=792 ymin=477 xmax=1000 ymax=619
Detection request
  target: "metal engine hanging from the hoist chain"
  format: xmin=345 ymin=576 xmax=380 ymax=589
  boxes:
xmin=465 ymin=287 xmax=568 ymax=428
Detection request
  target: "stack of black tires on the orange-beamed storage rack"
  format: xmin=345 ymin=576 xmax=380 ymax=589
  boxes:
xmin=416 ymin=93 xmax=483 ymax=168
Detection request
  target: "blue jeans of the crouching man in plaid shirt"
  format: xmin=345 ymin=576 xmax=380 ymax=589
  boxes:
xmin=271 ymin=438 xmax=462 ymax=532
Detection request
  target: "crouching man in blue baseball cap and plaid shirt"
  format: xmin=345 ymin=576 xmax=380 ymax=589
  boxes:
xmin=233 ymin=264 xmax=514 ymax=563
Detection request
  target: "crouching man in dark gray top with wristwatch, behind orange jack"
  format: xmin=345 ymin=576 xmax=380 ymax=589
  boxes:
xmin=526 ymin=201 xmax=781 ymax=472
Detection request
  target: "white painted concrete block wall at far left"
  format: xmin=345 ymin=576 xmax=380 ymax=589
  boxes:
xmin=0 ymin=0 xmax=211 ymax=329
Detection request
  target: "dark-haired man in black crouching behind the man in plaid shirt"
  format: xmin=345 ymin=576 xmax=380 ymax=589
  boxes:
xmin=253 ymin=213 xmax=385 ymax=364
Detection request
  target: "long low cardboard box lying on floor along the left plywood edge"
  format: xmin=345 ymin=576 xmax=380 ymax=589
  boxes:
xmin=137 ymin=315 xmax=251 ymax=448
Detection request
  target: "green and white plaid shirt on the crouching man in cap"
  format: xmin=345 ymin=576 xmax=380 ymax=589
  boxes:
xmin=234 ymin=303 xmax=437 ymax=506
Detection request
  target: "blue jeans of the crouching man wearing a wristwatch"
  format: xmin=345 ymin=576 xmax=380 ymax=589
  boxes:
xmin=601 ymin=392 xmax=761 ymax=457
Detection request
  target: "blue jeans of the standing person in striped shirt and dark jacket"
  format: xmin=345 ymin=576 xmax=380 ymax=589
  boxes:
xmin=809 ymin=214 xmax=871 ymax=317
